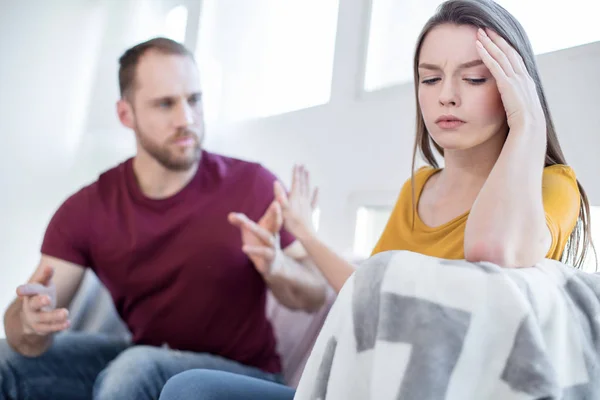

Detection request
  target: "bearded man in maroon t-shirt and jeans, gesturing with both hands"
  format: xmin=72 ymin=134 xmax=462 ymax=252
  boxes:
xmin=0 ymin=38 xmax=325 ymax=400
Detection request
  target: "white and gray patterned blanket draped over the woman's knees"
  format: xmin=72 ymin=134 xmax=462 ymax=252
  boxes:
xmin=295 ymin=251 xmax=600 ymax=400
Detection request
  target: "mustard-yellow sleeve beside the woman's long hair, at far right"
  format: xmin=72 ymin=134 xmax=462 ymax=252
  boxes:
xmin=542 ymin=165 xmax=581 ymax=260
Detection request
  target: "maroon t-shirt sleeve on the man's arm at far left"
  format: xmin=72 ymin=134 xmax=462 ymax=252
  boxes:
xmin=41 ymin=189 xmax=91 ymax=267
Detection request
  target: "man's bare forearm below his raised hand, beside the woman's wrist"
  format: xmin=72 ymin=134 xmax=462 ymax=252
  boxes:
xmin=265 ymin=254 xmax=327 ymax=312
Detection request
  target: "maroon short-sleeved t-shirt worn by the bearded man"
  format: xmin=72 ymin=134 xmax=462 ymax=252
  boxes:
xmin=42 ymin=151 xmax=294 ymax=373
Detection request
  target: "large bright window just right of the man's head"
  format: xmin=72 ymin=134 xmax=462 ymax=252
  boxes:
xmin=197 ymin=0 xmax=338 ymax=121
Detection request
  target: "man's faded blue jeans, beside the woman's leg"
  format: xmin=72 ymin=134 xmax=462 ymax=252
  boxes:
xmin=0 ymin=333 xmax=281 ymax=400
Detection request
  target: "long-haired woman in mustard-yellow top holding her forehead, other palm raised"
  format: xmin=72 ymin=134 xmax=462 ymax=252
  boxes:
xmin=161 ymin=0 xmax=590 ymax=400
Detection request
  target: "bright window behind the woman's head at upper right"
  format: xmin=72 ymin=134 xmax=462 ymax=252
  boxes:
xmin=364 ymin=0 xmax=600 ymax=91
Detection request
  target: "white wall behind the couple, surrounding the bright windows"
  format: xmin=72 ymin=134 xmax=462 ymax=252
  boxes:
xmin=0 ymin=0 xmax=600 ymax=336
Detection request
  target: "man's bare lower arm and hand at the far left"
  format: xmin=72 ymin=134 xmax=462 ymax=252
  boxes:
xmin=4 ymin=255 xmax=85 ymax=357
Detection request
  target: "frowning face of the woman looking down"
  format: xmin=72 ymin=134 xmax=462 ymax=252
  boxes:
xmin=418 ymin=24 xmax=508 ymax=150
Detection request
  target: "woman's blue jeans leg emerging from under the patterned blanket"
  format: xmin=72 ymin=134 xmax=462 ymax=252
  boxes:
xmin=159 ymin=370 xmax=294 ymax=400
